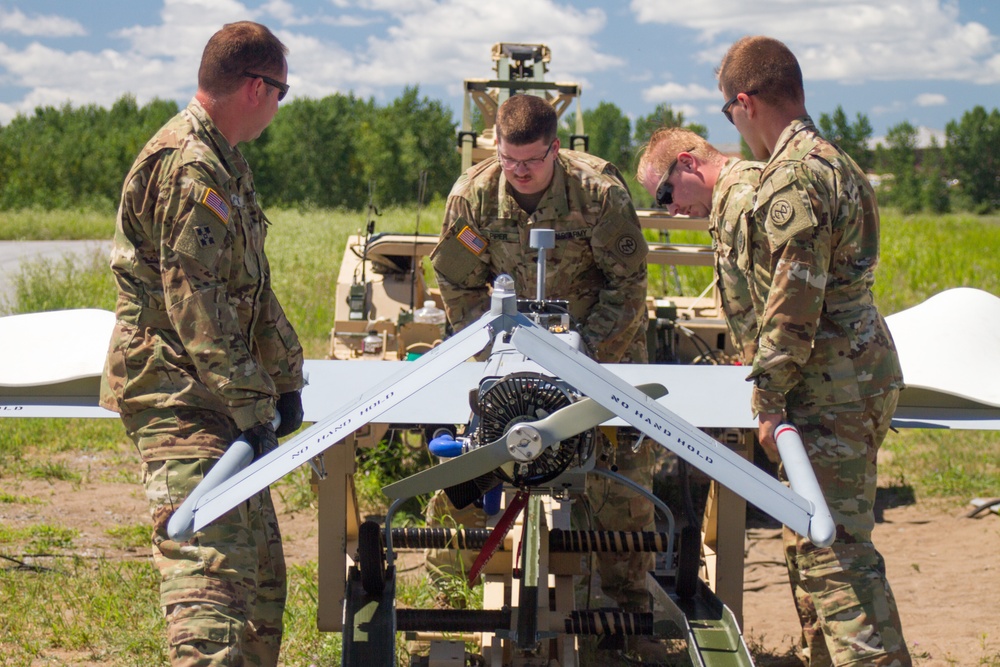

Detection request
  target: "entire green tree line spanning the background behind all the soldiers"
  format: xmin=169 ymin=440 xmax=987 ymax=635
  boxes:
xmin=0 ymin=87 xmax=1000 ymax=213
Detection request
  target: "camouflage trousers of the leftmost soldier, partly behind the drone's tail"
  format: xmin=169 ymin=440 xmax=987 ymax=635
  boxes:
xmin=126 ymin=410 xmax=287 ymax=667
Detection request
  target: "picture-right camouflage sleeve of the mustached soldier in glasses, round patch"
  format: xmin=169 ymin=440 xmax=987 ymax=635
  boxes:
xmin=580 ymin=187 xmax=649 ymax=363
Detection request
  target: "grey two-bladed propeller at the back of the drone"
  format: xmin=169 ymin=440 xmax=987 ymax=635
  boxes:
xmin=382 ymin=383 xmax=667 ymax=499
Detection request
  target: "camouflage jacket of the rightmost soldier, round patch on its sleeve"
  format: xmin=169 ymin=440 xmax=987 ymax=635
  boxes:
xmin=750 ymin=117 xmax=902 ymax=413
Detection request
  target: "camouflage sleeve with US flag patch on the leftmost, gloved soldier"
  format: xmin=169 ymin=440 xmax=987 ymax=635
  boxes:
xmin=157 ymin=165 xmax=275 ymax=430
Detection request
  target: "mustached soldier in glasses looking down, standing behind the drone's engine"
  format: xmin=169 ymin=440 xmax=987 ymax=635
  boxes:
xmin=431 ymin=95 xmax=653 ymax=610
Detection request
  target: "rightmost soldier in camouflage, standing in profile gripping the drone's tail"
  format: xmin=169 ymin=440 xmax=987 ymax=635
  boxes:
xmin=719 ymin=37 xmax=911 ymax=665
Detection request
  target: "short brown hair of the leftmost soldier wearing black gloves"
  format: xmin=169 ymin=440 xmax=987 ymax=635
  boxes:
xmin=198 ymin=21 xmax=288 ymax=95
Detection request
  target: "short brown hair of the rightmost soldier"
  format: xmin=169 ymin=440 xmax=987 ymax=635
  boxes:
xmin=717 ymin=35 xmax=805 ymax=106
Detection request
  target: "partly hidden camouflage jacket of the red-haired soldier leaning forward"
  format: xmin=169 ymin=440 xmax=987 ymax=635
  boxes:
xmin=709 ymin=158 xmax=763 ymax=365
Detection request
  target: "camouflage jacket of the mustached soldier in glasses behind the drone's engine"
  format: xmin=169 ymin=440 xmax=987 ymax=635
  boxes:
xmin=431 ymin=150 xmax=648 ymax=362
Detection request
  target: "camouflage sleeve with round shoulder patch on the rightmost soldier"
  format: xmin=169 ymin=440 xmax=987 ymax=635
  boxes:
xmin=750 ymin=163 xmax=835 ymax=414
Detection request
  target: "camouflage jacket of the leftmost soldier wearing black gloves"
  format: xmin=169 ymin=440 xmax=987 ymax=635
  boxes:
xmin=101 ymin=100 xmax=303 ymax=460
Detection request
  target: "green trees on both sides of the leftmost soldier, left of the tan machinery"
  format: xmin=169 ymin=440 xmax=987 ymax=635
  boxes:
xmin=0 ymin=88 xmax=461 ymax=211
